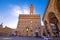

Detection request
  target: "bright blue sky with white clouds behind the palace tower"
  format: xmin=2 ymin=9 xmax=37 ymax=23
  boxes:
xmin=0 ymin=0 xmax=48 ymax=28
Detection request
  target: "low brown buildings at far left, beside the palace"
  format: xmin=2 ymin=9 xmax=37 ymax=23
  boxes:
xmin=0 ymin=24 xmax=14 ymax=36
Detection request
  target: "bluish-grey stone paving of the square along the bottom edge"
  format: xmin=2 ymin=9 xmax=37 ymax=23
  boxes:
xmin=0 ymin=37 xmax=60 ymax=40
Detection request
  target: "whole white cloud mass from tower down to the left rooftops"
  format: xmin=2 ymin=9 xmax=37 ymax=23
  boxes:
xmin=3 ymin=5 xmax=29 ymax=29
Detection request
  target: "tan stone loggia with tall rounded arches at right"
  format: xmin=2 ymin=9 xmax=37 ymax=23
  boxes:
xmin=43 ymin=0 xmax=60 ymax=37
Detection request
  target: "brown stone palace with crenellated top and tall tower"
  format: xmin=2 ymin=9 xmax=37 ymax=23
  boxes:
xmin=17 ymin=4 xmax=41 ymax=37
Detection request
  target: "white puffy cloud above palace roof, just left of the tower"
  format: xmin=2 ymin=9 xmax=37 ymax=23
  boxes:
xmin=12 ymin=5 xmax=29 ymax=16
